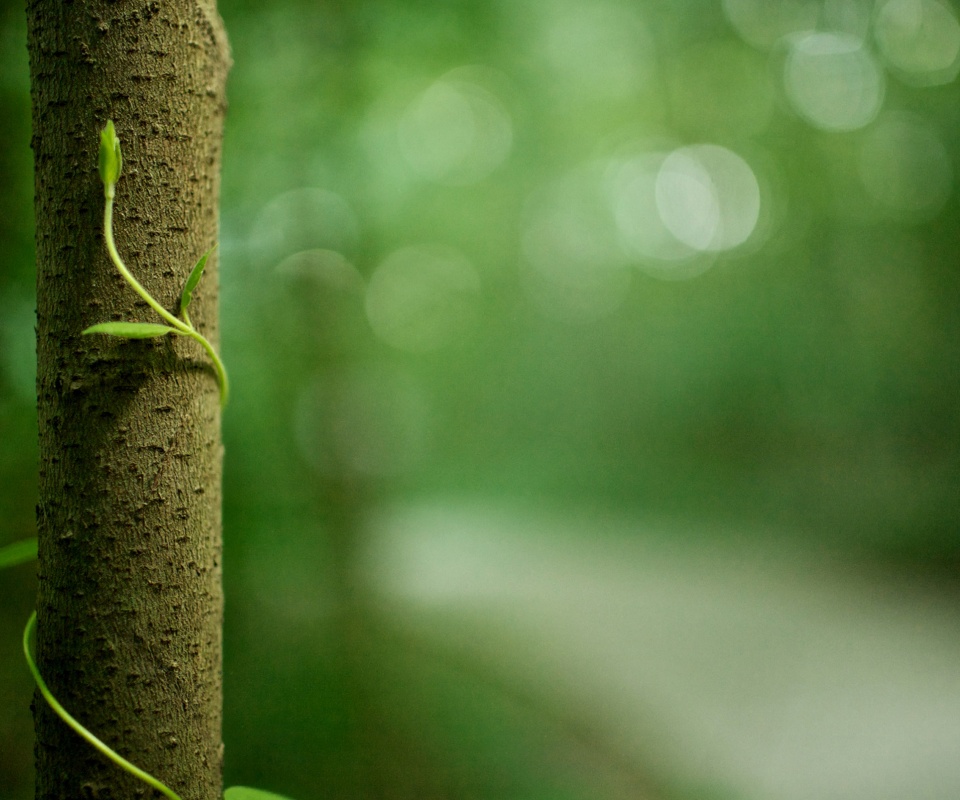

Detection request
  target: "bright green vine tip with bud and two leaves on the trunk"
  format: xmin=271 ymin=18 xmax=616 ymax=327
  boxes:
xmin=83 ymin=120 xmax=230 ymax=407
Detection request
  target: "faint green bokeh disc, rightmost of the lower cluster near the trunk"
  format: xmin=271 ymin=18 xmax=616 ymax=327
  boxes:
xmin=366 ymin=245 xmax=480 ymax=353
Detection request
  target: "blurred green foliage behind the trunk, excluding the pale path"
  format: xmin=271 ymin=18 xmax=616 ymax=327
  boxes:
xmin=0 ymin=0 xmax=960 ymax=800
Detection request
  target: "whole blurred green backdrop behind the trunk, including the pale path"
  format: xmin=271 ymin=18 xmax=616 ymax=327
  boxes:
xmin=0 ymin=0 xmax=960 ymax=800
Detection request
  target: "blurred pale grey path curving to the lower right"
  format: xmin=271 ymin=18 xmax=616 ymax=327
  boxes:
xmin=371 ymin=507 xmax=960 ymax=800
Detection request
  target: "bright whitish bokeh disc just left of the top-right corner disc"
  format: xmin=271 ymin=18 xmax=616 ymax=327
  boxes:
xmin=784 ymin=33 xmax=885 ymax=131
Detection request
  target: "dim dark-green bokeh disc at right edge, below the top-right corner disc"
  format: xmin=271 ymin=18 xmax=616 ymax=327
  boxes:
xmin=859 ymin=113 xmax=953 ymax=221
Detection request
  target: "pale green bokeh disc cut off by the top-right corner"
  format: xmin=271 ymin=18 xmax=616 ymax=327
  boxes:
xmin=875 ymin=0 xmax=960 ymax=86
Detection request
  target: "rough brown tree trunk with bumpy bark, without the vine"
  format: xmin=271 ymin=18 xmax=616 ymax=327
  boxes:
xmin=27 ymin=0 xmax=229 ymax=800
